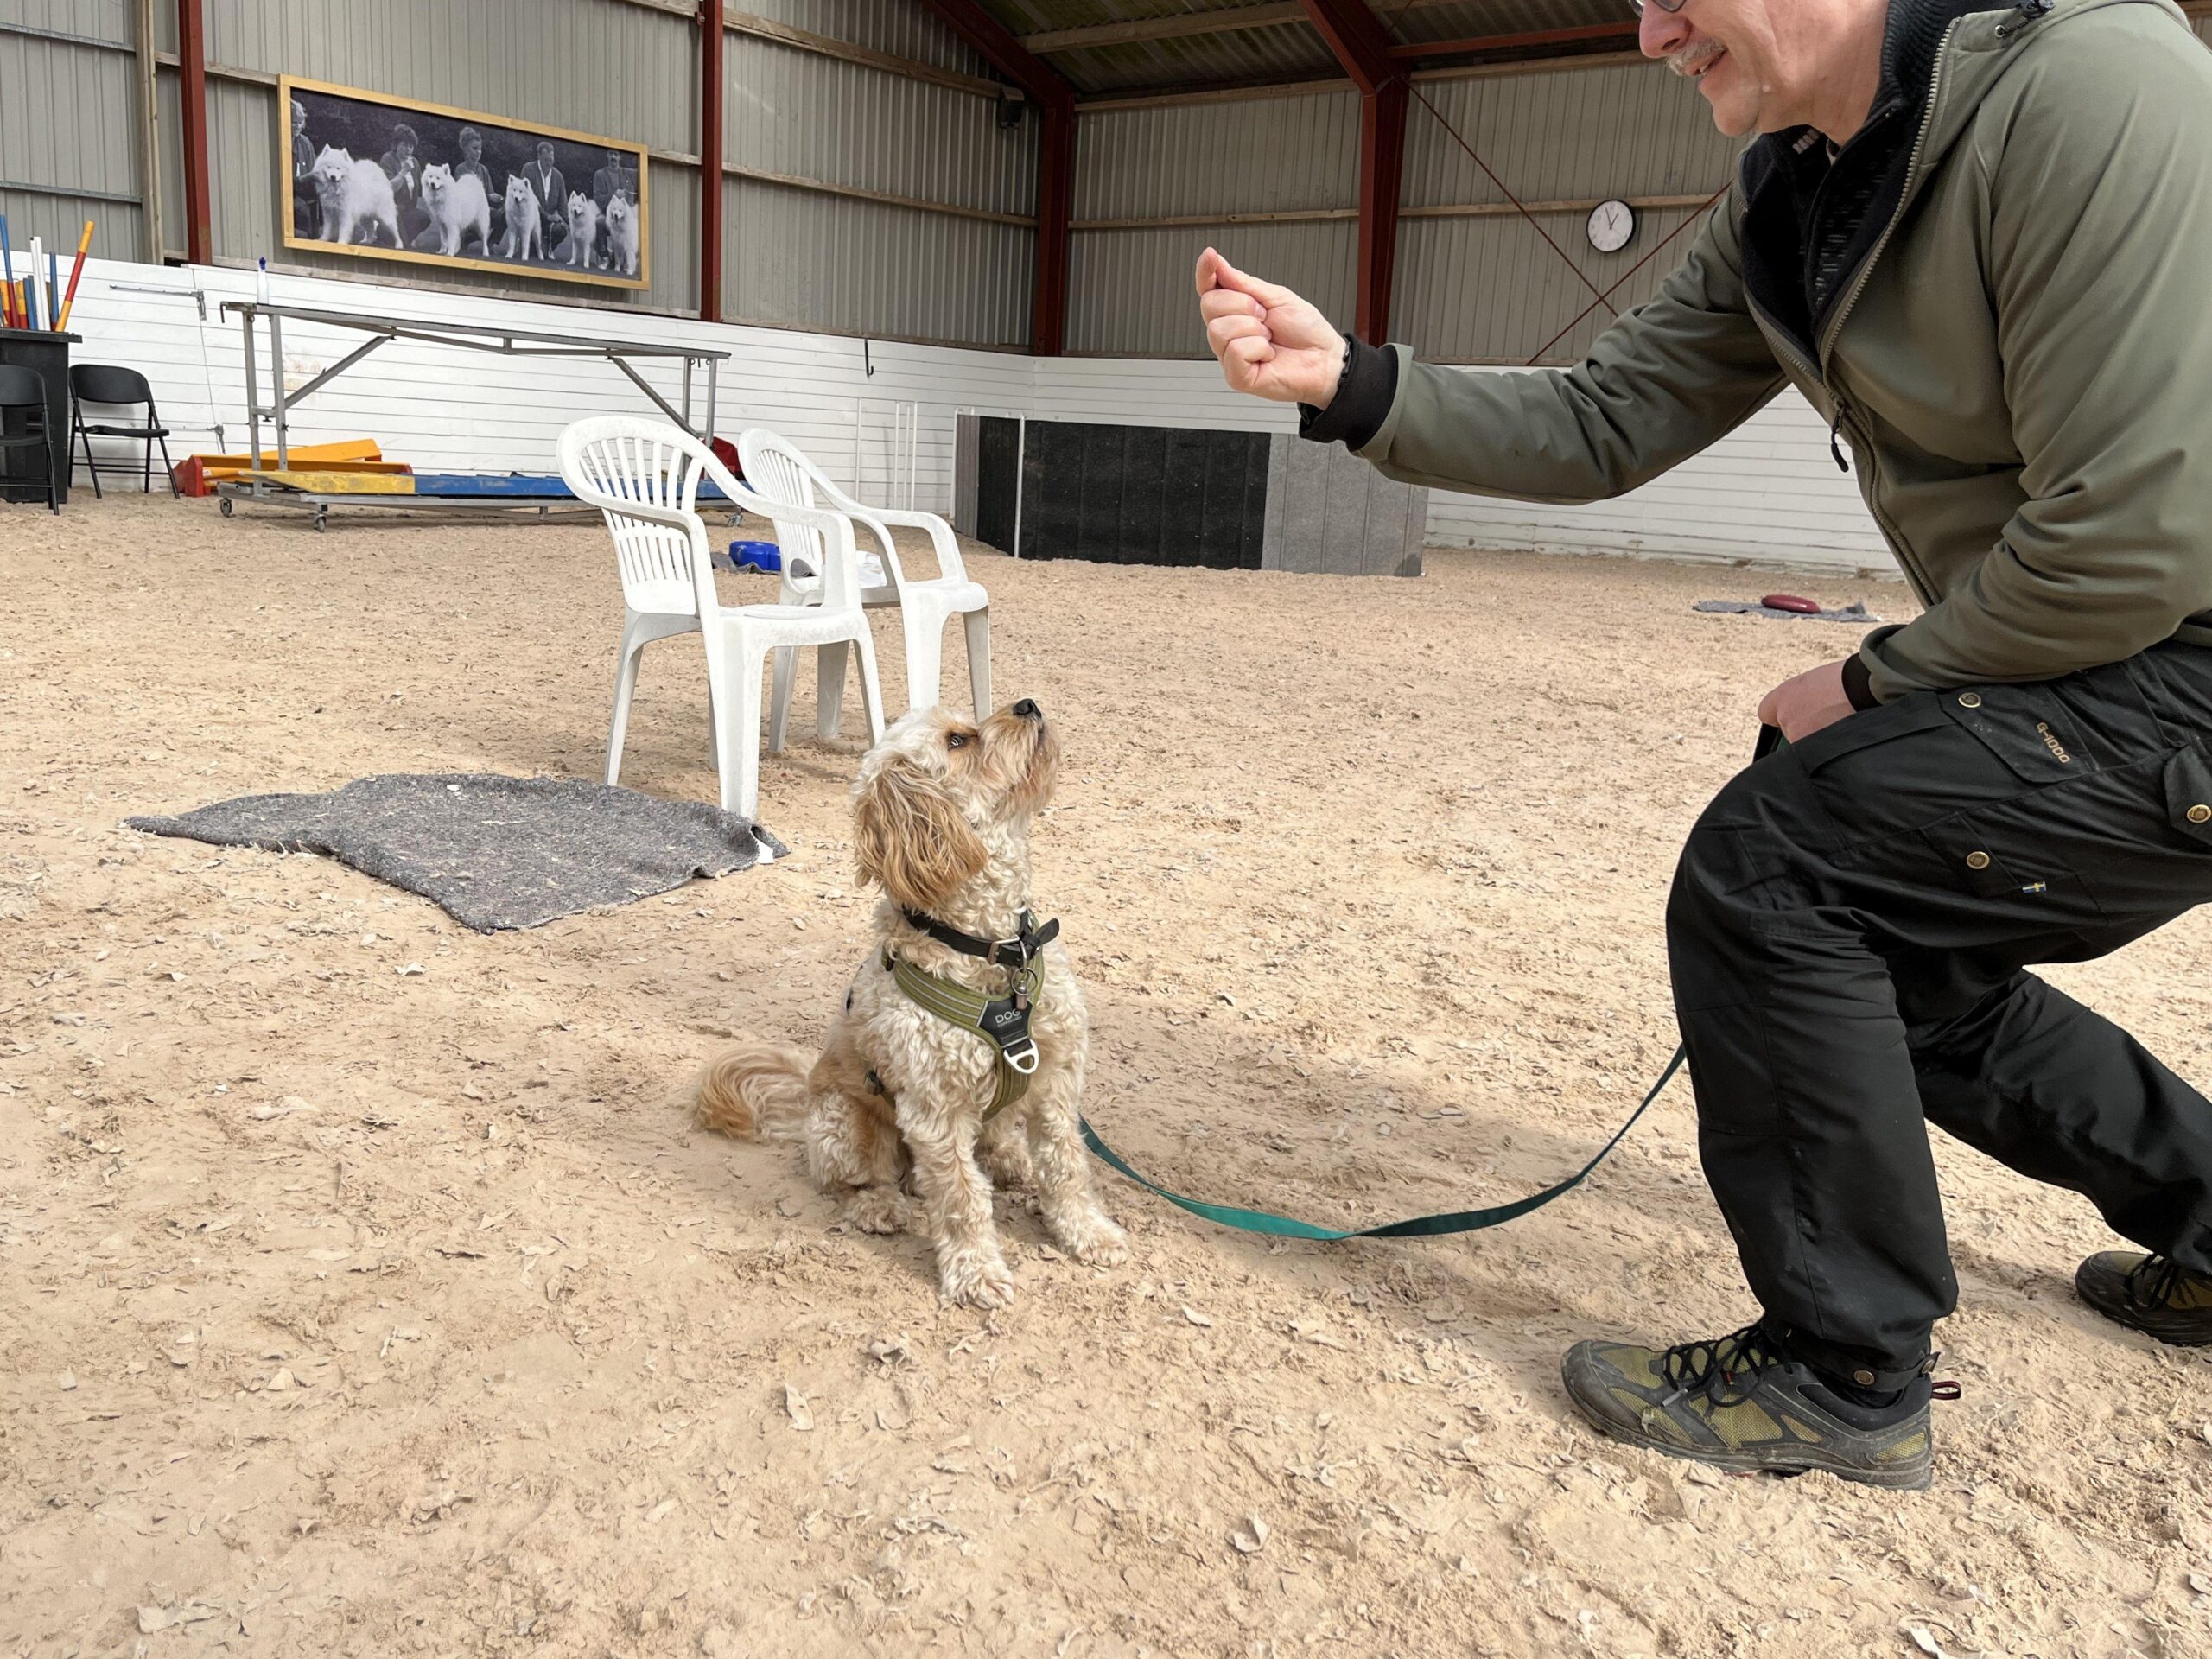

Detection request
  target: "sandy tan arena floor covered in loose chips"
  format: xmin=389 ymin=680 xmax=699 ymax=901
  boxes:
xmin=0 ymin=498 xmax=2212 ymax=1659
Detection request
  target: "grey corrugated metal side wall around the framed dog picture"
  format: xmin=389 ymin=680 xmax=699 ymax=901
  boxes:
xmin=0 ymin=0 xmax=1039 ymax=347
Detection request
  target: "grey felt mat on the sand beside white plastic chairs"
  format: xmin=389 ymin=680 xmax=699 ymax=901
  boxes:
xmin=124 ymin=772 xmax=790 ymax=933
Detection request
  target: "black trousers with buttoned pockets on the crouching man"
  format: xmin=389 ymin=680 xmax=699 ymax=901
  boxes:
xmin=1668 ymin=646 xmax=2212 ymax=1387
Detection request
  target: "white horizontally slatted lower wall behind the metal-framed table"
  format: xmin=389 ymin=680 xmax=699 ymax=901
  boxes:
xmin=75 ymin=261 xmax=1893 ymax=573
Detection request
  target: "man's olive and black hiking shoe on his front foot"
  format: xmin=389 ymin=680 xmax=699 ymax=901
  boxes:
xmin=1560 ymin=1325 xmax=1948 ymax=1489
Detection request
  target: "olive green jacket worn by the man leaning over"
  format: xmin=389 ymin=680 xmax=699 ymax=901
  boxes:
xmin=1358 ymin=0 xmax=2212 ymax=702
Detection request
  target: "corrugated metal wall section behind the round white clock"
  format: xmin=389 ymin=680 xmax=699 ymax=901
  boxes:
xmin=1389 ymin=64 xmax=1738 ymax=363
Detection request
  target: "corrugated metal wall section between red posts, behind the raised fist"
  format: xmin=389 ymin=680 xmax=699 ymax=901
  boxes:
xmin=1068 ymin=93 xmax=1360 ymax=356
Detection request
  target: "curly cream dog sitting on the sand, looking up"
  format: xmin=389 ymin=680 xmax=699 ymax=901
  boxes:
xmin=692 ymin=699 xmax=1128 ymax=1307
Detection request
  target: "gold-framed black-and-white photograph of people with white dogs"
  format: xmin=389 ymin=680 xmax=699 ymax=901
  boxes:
xmin=279 ymin=75 xmax=651 ymax=288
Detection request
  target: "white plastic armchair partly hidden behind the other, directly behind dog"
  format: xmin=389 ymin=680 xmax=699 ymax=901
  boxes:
xmin=736 ymin=427 xmax=991 ymax=750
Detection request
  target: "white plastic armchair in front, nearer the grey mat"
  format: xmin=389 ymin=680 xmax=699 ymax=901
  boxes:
xmin=560 ymin=416 xmax=882 ymax=818
